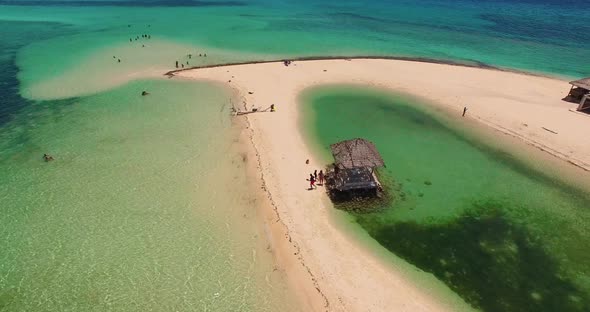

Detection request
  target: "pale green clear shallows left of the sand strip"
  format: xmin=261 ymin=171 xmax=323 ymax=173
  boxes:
xmin=0 ymin=80 xmax=293 ymax=311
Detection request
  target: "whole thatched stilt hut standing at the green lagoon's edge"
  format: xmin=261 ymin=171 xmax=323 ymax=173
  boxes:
xmin=327 ymin=139 xmax=385 ymax=198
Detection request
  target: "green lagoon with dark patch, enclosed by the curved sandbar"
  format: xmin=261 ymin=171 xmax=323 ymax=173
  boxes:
xmin=304 ymin=87 xmax=590 ymax=311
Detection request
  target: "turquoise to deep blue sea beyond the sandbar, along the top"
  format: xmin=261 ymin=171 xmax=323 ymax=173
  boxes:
xmin=0 ymin=0 xmax=590 ymax=101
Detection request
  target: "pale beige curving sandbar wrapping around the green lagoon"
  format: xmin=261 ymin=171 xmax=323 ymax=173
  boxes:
xmin=169 ymin=59 xmax=590 ymax=311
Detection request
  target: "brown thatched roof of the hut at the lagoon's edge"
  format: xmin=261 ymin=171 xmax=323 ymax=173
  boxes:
xmin=330 ymin=139 xmax=385 ymax=168
